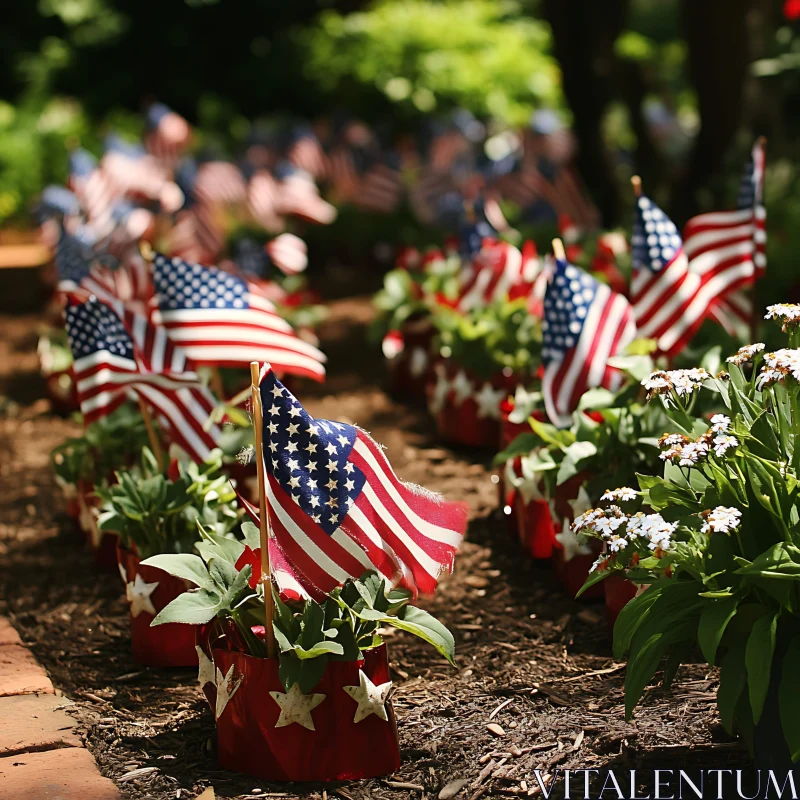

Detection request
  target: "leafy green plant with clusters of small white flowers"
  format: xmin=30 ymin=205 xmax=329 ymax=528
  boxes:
xmin=573 ymin=312 xmax=800 ymax=768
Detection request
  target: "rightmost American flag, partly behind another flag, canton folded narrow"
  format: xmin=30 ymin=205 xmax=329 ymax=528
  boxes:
xmin=683 ymin=139 xmax=767 ymax=316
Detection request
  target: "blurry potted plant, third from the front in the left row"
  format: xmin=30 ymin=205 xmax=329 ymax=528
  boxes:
xmin=50 ymin=404 xmax=147 ymax=570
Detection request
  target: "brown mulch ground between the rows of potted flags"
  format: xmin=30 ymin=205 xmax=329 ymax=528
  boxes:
xmin=0 ymin=299 xmax=748 ymax=800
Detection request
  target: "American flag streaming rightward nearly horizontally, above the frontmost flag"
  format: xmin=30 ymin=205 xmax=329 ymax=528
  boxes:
xmin=153 ymin=253 xmax=325 ymax=381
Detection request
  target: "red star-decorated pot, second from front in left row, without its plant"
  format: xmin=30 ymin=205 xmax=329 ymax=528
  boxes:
xmin=117 ymin=545 xmax=197 ymax=667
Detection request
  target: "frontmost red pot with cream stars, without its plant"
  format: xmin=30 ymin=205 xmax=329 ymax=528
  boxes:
xmin=201 ymin=645 xmax=400 ymax=781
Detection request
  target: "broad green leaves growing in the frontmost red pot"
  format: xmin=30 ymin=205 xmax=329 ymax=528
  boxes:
xmin=144 ymin=522 xmax=454 ymax=692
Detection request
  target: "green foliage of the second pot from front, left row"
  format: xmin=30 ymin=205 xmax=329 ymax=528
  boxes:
xmin=95 ymin=448 xmax=241 ymax=558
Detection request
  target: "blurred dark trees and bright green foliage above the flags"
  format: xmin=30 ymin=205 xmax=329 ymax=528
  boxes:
xmin=0 ymin=0 xmax=800 ymax=296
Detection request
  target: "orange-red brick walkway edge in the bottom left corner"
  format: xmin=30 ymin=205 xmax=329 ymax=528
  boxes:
xmin=0 ymin=617 xmax=120 ymax=800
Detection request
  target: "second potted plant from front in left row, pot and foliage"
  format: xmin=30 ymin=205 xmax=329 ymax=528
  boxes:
xmin=97 ymin=448 xmax=240 ymax=666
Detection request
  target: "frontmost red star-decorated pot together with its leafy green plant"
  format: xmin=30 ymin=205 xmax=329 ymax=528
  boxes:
xmin=144 ymin=522 xmax=454 ymax=781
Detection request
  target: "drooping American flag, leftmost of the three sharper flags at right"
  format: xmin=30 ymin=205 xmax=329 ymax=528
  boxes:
xmin=542 ymin=259 xmax=636 ymax=426
